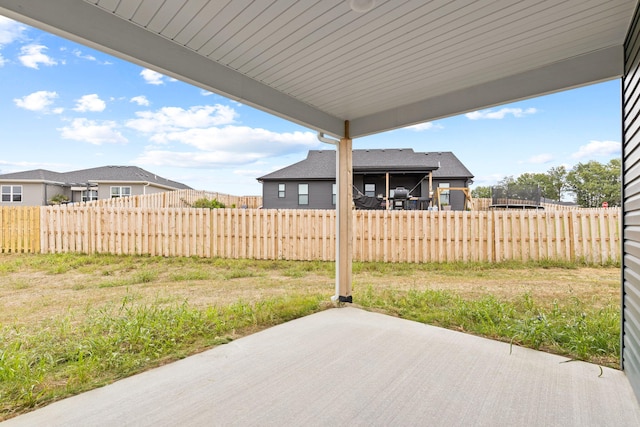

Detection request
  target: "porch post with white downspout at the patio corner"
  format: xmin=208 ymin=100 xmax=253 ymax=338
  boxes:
xmin=334 ymin=137 xmax=353 ymax=302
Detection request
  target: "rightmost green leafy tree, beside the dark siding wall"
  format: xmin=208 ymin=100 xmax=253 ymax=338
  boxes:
xmin=567 ymin=159 xmax=621 ymax=208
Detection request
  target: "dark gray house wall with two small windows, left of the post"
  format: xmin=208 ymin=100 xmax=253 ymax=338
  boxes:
xmin=262 ymin=181 xmax=335 ymax=209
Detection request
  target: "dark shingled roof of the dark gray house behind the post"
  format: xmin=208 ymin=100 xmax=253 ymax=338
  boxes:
xmin=258 ymin=148 xmax=473 ymax=182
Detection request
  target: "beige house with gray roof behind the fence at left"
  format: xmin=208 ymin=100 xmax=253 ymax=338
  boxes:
xmin=0 ymin=166 xmax=191 ymax=206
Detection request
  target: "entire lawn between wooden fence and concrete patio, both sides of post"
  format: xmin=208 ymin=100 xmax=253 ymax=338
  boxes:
xmin=0 ymin=254 xmax=620 ymax=420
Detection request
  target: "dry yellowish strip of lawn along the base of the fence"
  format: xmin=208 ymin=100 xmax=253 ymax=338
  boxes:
xmin=0 ymin=254 xmax=620 ymax=325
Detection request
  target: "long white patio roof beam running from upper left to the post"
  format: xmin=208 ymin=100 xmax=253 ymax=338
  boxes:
xmin=0 ymin=0 xmax=344 ymax=138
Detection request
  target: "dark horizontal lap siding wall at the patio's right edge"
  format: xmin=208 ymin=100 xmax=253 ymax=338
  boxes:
xmin=621 ymin=2 xmax=640 ymax=397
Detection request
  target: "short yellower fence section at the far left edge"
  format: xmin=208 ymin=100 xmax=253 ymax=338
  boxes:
xmin=0 ymin=206 xmax=40 ymax=253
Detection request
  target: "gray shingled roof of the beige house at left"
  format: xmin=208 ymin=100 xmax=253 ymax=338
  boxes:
xmin=0 ymin=166 xmax=191 ymax=190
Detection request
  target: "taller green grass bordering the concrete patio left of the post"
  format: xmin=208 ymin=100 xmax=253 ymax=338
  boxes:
xmin=0 ymin=295 xmax=327 ymax=418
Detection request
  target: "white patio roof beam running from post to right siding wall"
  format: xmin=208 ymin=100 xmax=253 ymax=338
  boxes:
xmin=349 ymin=46 xmax=624 ymax=138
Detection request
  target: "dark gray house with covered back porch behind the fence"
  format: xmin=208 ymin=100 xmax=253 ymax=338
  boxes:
xmin=258 ymin=148 xmax=473 ymax=210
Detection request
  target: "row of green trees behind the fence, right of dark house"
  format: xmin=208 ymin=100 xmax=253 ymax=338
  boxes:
xmin=471 ymin=159 xmax=622 ymax=208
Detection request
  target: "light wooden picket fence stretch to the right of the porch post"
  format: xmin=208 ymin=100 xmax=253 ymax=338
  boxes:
xmin=354 ymin=209 xmax=620 ymax=263
